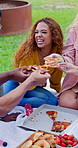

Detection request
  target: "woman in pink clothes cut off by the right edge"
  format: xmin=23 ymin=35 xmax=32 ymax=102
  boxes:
xmin=47 ymin=14 xmax=78 ymax=110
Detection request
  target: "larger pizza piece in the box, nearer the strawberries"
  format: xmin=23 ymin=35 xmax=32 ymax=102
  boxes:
xmin=51 ymin=121 xmax=71 ymax=132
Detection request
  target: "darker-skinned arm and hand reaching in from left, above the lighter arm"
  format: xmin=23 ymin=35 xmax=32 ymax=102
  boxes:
xmin=0 ymin=66 xmax=29 ymax=85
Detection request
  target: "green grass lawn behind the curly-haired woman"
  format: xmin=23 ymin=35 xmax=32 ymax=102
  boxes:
xmin=0 ymin=0 xmax=78 ymax=73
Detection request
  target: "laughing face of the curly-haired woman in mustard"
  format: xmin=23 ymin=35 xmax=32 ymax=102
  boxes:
xmin=35 ymin=22 xmax=52 ymax=48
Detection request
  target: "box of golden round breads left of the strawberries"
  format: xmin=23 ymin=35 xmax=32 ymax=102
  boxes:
xmin=17 ymin=130 xmax=57 ymax=148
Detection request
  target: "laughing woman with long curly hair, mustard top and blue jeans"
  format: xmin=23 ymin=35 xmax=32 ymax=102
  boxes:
xmin=4 ymin=17 xmax=63 ymax=107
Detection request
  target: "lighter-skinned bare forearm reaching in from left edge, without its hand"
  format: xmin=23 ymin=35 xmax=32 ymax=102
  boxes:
xmin=0 ymin=78 xmax=32 ymax=117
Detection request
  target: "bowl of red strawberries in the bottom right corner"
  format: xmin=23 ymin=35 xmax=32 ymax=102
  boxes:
xmin=56 ymin=134 xmax=78 ymax=148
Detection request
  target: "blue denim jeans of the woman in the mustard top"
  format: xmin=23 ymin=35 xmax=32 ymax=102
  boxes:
xmin=3 ymin=80 xmax=58 ymax=108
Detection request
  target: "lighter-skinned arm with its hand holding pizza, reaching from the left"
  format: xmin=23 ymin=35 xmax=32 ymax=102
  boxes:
xmin=0 ymin=71 xmax=50 ymax=117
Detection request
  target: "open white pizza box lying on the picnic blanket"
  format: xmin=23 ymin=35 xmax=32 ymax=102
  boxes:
xmin=18 ymin=104 xmax=78 ymax=135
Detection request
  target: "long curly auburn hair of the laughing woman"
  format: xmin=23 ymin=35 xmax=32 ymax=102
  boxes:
xmin=14 ymin=17 xmax=63 ymax=68
